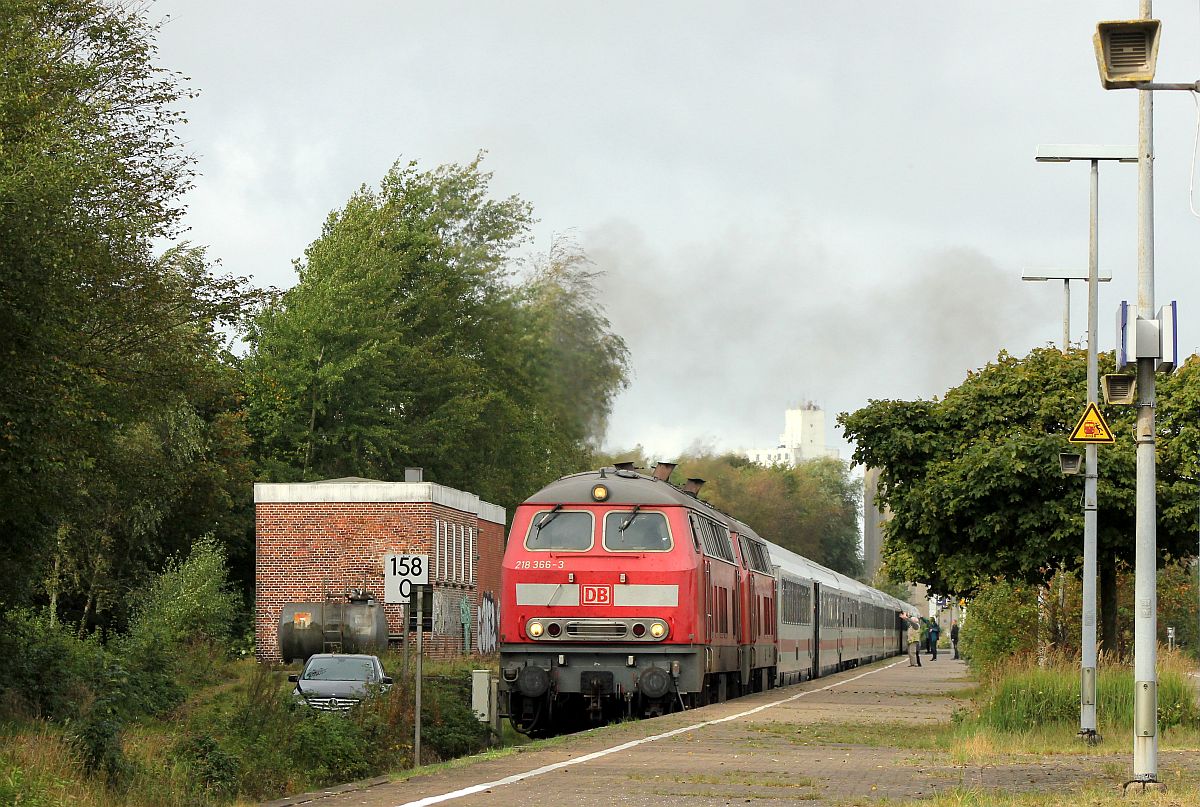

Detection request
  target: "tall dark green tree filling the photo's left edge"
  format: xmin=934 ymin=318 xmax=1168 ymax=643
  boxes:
xmin=0 ymin=0 xmax=261 ymax=622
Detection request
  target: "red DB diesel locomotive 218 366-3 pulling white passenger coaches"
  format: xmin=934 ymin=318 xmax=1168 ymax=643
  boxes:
xmin=499 ymin=462 xmax=911 ymax=736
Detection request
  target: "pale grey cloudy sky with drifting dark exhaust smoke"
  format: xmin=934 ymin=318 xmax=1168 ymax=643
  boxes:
xmin=150 ymin=0 xmax=1200 ymax=456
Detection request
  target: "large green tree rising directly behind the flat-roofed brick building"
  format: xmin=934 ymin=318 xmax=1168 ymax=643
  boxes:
xmin=245 ymin=157 xmax=628 ymax=504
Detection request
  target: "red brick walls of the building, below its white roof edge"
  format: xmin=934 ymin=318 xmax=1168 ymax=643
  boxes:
xmin=254 ymin=491 xmax=504 ymax=662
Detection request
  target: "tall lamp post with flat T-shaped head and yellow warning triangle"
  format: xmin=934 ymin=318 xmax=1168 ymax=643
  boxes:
xmin=1037 ymin=145 xmax=1138 ymax=742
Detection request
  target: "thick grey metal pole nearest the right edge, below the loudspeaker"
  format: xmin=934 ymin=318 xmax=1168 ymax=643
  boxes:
xmin=1133 ymin=0 xmax=1158 ymax=782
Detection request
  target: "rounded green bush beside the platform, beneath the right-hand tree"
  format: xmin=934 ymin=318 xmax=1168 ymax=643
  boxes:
xmin=959 ymin=580 xmax=1038 ymax=674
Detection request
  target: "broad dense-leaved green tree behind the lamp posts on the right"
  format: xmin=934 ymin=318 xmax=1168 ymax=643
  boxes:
xmin=839 ymin=347 xmax=1200 ymax=647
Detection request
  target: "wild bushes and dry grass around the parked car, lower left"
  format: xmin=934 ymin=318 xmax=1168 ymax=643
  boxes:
xmin=0 ymin=539 xmax=498 ymax=806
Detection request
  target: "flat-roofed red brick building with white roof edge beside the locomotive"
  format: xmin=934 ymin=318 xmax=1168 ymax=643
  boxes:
xmin=254 ymin=476 xmax=505 ymax=662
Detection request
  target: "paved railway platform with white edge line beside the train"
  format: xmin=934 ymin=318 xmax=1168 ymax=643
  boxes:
xmin=271 ymin=653 xmax=1195 ymax=807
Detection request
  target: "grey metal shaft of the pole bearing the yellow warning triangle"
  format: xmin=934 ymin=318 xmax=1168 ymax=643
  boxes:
xmin=1079 ymin=160 xmax=1100 ymax=741
